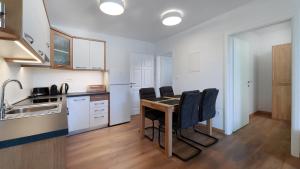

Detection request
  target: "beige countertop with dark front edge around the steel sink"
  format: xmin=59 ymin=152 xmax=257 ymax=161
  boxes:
xmin=0 ymin=96 xmax=68 ymax=149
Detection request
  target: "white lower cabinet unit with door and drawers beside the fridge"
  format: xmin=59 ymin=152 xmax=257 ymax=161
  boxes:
xmin=67 ymin=96 xmax=109 ymax=133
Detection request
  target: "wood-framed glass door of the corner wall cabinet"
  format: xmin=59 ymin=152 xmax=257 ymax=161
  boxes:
xmin=51 ymin=30 xmax=72 ymax=69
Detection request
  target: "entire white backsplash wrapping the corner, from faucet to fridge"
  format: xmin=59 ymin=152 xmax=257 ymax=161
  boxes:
xmin=0 ymin=58 xmax=103 ymax=104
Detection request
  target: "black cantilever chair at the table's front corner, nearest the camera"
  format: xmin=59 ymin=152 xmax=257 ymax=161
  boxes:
xmin=158 ymin=91 xmax=202 ymax=161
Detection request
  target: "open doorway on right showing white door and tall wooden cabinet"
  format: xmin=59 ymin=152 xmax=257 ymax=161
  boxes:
xmin=230 ymin=21 xmax=292 ymax=131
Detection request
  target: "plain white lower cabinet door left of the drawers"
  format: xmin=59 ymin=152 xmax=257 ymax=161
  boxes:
xmin=68 ymin=96 xmax=90 ymax=132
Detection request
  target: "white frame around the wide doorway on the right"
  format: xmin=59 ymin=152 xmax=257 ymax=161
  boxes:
xmin=223 ymin=18 xmax=300 ymax=157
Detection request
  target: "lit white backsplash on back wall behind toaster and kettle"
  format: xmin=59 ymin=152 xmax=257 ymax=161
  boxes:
xmin=25 ymin=68 xmax=103 ymax=92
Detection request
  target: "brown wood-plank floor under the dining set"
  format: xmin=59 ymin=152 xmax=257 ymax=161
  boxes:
xmin=67 ymin=116 xmax=300 ymax=169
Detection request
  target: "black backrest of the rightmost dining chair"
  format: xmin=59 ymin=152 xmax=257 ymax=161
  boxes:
xmin=199 ymin=88 xmax=219 ymax=122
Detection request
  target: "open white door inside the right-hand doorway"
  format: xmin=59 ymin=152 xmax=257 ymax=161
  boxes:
xmin=233 ymin=38 xmax=252 ymax=131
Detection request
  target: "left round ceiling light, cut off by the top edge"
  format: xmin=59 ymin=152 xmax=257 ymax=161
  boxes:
xmin=99 ymin=0 xmax=125 ymax=15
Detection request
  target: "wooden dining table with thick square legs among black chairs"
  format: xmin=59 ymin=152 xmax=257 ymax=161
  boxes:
xmin=140 ymin=97 xmax=180 ymax=157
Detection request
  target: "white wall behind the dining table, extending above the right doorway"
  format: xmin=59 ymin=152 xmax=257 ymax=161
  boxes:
xmin=157 ymin=0 xmax=300 ymax=131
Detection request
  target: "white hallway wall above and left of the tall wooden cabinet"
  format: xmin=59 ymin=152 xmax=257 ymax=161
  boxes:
xmin=237 ymin=22 xmax=292 ymax=112
